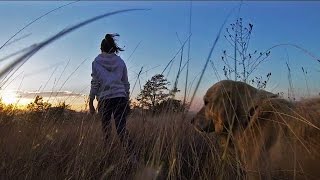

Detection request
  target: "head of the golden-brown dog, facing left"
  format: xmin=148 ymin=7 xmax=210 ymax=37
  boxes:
xmin=192 ymin=80 xmax=277 ymax=134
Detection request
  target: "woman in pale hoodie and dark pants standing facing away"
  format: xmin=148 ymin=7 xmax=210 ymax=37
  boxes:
xmin=89 ymin=34 xmax=131 ymax=148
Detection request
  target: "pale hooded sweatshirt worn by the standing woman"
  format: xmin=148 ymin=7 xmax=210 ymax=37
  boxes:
xmin=89 ymin=53 xmax=130 ymax=100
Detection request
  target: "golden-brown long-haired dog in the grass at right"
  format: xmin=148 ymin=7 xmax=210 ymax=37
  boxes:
xmin=192 ymin=80 xmax=320 ymax=179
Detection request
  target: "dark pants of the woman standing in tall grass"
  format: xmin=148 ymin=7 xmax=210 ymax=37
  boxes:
xmin=98 ymin=97 xmax=132 ymax=150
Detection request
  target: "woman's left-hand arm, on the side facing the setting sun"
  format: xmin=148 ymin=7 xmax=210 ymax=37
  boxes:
xmin=89 ymin=62 xmax=100 ymax=114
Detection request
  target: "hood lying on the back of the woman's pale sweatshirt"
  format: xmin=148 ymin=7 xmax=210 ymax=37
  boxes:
xmin=96 ymin=53 xmax=120 ymax=72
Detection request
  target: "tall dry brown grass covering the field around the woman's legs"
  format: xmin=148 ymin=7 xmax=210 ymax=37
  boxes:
xmin=0 ymin=109 xmax=241 ymax=179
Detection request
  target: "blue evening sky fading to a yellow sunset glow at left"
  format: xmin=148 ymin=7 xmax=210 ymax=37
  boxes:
xmin=0 ymin=1 xmax=320 ymax=109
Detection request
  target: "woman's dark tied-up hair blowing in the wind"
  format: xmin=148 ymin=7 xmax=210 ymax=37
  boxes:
xmin=100 ymin=34 xmax=123 ymax=53
